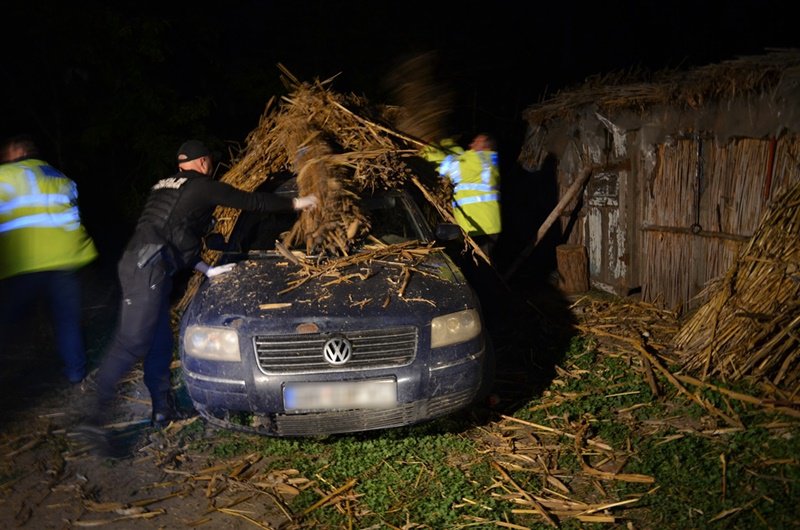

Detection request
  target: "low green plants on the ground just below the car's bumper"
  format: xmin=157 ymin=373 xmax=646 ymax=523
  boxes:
xmin=191 ymin=418 xmax=497 ymax=528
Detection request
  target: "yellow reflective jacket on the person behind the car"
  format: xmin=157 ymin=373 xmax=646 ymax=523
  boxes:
xmin=420 ymin=140 xmax=502 ymax=236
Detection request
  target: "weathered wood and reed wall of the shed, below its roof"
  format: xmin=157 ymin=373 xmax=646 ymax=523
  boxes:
xmin=562 ymin=134 xmax=800 ymax=312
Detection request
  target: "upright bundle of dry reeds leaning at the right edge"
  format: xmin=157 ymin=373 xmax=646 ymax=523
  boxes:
xmin=673 ymin=179 xmax=800 ymax=388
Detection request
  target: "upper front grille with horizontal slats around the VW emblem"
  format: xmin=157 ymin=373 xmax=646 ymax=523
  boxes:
xmin=253 ymin=328 xmax=417 ymax=373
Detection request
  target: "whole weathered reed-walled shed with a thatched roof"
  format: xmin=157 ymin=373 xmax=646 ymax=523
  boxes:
xmin=519 ymin=50 xmax=800 ymax=309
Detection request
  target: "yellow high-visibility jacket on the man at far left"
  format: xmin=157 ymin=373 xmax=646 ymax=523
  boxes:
xmin=0 ymin=158 xmax=97 ymax=279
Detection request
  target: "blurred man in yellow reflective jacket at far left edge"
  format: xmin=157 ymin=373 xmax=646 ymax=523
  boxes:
xmin=0 ymin=135 xmax=97 ymax=383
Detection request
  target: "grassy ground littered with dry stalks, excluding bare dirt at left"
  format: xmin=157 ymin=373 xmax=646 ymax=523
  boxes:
xmin=167 ymin=290 xmax=800 ymax=529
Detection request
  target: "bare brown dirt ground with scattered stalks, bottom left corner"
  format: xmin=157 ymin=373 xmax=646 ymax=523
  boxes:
xmin=0 ymin=368 xmax=304 ymax=529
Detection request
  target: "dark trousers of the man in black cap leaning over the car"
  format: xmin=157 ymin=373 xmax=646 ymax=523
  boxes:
xmin=92 ymin=252 xmax=172 ymax=422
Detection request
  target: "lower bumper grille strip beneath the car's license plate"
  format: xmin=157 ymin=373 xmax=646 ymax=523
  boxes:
xmin=272 ymin=390 xmax=475 ymax=436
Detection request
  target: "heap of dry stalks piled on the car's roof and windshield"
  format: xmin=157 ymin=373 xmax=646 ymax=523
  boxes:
xmin=175 ymin=69 xmax=462 ymax=313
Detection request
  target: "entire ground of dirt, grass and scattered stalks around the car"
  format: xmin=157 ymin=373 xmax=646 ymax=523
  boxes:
xmin=0 ymin=270 xmax=800 ymax=529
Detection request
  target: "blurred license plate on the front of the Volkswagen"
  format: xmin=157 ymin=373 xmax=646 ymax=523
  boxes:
xmin=283 ymin=380 xmax=397 ymax=411
